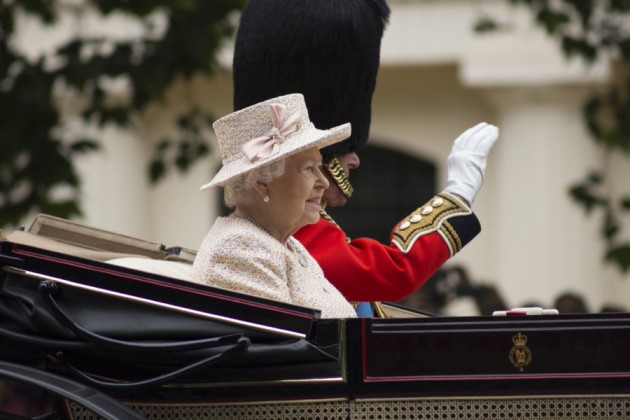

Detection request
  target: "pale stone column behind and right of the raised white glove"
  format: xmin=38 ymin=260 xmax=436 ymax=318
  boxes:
xmin=478 ymin=87 xmax=603 ymax=305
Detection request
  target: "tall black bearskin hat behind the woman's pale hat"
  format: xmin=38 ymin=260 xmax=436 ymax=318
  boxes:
xmin=233 ymin=0 xmax=389 ymax=157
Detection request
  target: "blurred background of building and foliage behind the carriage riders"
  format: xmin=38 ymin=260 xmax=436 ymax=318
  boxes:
xmin=0 ymin=0 xmax=630 ymax=315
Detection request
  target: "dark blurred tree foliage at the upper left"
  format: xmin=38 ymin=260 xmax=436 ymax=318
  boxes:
xmin=0 ymin=0 xmax=246 ymax=227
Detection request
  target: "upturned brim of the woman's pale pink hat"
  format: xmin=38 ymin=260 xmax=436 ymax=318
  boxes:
xmin=199 ymin=123 xmax=352 ymax=190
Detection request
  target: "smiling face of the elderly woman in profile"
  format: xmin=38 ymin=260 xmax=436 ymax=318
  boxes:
xmin=266 ymin=147 xmax=328 ymax=235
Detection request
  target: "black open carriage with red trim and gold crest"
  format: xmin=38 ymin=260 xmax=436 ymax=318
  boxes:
xmin=0 ymin=217 xmax=630 ymax=419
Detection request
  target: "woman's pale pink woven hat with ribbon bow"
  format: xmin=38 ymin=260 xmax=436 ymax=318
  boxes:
xmin=201 ymin=93 xmax=351 ymax=190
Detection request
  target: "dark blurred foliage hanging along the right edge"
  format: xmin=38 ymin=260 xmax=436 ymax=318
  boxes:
xmin=475 ymin=0 xmax=630 ymax=272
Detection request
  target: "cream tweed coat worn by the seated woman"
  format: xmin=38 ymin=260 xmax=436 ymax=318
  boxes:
xmin=192 ymin=217 xmax=356 ymax=318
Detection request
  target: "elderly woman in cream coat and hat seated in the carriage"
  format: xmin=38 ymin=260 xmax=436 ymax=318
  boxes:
xmin=193 ymin=94 xmax=356 ymax=318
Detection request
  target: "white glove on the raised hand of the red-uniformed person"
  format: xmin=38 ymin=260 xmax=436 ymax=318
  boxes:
xmin=444 ymin=122 xmax=499 ymax=204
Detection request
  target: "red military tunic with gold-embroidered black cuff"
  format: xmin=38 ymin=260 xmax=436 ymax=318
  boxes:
xmin=294 ymin=193 xmax=481 ymax=302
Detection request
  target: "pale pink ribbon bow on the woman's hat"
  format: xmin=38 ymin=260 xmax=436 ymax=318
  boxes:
xmin=242 ymin=104 xmax=300 ymax=162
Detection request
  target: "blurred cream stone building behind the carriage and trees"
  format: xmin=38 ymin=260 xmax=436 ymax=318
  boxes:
xmin=12 ymin=0 xmax=630 ymax=310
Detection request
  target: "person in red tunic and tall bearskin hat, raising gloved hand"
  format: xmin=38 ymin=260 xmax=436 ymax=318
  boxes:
xmin=233 ymin=0 xmax=498 ymax=315
